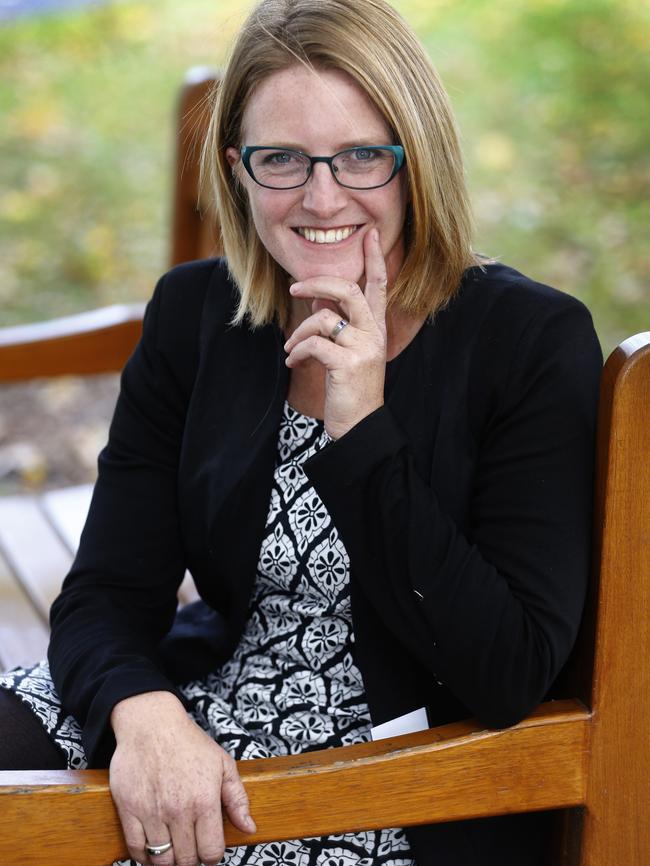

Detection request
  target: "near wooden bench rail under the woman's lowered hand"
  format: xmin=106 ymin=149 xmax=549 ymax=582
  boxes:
xmin=0 ymin=701 xmax=591 ymax=866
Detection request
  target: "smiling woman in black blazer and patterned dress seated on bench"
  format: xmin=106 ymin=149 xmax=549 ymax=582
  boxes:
xmin=3 ymin=0 xmax=602 ymax=866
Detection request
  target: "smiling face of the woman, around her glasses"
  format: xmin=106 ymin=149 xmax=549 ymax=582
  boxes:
xmin=226 ymin=64 xmax=407 ymax=285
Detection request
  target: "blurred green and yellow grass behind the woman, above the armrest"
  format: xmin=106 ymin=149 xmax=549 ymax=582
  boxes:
xmin=0 ymin=0 xmax=650 ymax=350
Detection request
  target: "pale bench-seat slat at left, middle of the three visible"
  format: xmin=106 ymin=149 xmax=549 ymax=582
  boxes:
xmin=0 ymin=496 xmax=72 ymax=622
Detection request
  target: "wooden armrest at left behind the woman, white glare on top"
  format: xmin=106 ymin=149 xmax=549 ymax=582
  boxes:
xmin=0 ymin=304 xmax=144 ymax=382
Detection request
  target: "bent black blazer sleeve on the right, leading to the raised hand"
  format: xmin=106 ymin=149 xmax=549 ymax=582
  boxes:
xmin=306 ymin=296 xmax=602 ymax=727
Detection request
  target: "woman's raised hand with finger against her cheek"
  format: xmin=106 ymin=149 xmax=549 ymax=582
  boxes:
xmin=284 ymin=229 xmax=387 ymax=439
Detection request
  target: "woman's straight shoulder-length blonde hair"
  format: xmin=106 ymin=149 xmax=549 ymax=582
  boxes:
xmin=201 ymin=0 xmax=480 ymax=326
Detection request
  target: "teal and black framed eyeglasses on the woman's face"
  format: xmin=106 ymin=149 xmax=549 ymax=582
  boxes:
xmin=240 ymin=144 xmax=404 ymax=189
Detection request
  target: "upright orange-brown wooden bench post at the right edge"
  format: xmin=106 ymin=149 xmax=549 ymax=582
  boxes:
xmin=580 ymin=333 xmax=650 ymax=866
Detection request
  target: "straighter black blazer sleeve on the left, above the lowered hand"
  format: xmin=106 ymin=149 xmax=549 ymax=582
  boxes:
xmin=48 ymin=269 xmax=208 ymax=765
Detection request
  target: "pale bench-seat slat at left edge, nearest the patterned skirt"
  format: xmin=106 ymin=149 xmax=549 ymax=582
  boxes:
xmin=0 ymin=555 xmax=48 ymax=671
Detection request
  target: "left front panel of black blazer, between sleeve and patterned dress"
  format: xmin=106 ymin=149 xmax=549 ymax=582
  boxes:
xmin=179 ymin=318 xmax=289 ymax=629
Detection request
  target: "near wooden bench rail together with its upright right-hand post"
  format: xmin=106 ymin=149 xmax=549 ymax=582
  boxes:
xmin=0 ymin=69 xmax=650 ymax=866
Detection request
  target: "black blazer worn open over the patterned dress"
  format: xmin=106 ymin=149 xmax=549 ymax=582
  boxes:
xmin=49 ymin=260 xmax=602 ymax=866
